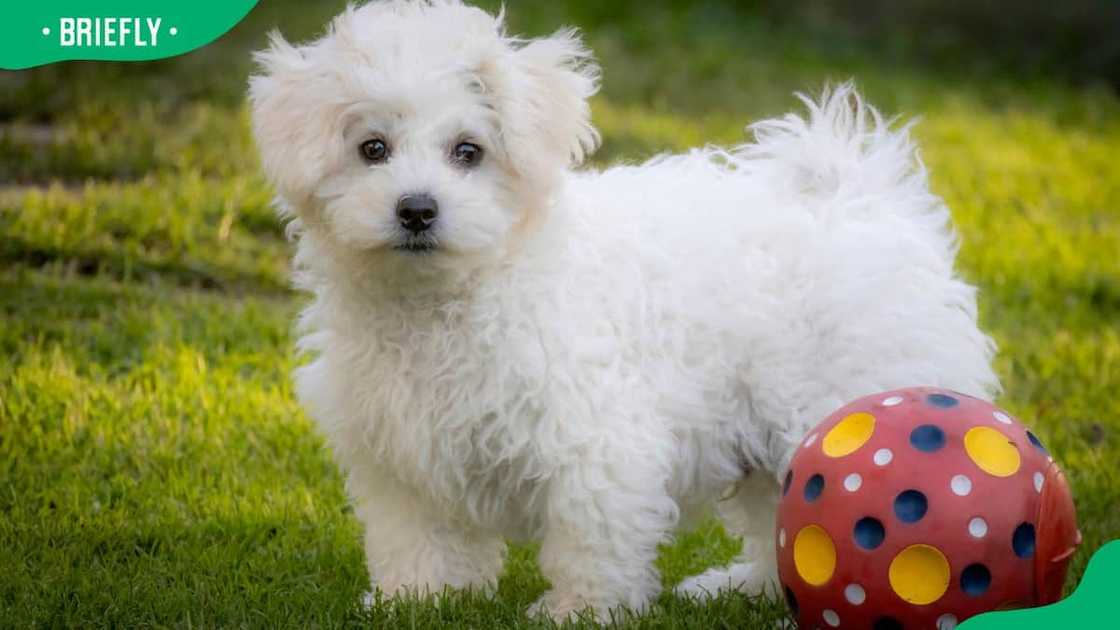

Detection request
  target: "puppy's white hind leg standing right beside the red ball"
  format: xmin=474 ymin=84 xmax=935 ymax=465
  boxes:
xmin=673 ymin=471 xmax=781 ymax=597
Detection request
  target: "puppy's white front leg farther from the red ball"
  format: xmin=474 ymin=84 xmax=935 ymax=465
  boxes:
xmin=351 ymin=472 xmax=505 ymax=596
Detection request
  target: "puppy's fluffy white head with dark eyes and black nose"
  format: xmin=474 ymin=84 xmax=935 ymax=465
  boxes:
xmin=250 ymin=0 xmax=598 ymax=274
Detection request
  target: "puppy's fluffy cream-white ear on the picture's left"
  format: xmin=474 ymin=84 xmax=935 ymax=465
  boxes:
xmin=249 ymin=31 xmax=339 ymax=207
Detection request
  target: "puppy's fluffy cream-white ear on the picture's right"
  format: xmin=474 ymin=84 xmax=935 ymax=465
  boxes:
xmin=479 ymin=29 xmax=599 ymax=180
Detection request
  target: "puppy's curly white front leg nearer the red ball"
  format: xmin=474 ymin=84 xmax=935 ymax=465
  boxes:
xmin=531 ymin=452 xmax=678 ymax=621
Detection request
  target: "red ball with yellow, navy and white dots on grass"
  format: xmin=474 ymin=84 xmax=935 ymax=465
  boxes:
xmin=776 ymin=388 xmax=1081 ymax=630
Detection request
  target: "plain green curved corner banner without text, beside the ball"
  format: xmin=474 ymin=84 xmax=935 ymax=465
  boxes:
xmin=960 ymin=540 xmax=1120 ymax=630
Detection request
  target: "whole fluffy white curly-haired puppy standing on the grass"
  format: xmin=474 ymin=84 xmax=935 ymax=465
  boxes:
xmin=251 ymin=0 xmax=998 ymax=618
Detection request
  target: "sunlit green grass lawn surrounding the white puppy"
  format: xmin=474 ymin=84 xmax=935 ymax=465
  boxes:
xmin=0 ymin=0 xmax=1120 ymax=628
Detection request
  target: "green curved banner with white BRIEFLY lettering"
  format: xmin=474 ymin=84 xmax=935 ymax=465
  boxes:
xmin=0 ymin=0 xmax=256 ymax=70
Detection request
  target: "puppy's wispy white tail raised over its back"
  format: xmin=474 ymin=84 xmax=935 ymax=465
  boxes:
xmin=732 ymin=82 xmax=949 ymax=223
